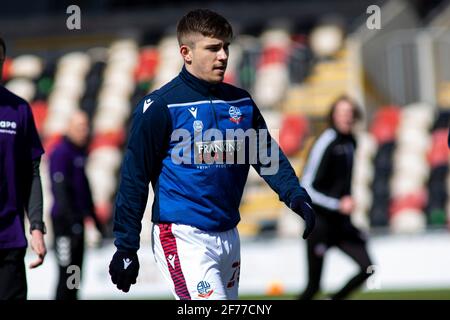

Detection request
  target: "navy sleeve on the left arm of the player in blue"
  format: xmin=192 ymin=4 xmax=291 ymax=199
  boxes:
xmin=113 ymin=96 xmax=171 ymax=252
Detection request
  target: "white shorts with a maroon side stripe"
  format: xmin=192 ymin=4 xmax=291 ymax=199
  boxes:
xmin=152 ymin=223 xmax=241 ymax=300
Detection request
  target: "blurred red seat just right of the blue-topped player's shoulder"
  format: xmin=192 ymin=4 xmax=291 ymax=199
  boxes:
xmin=280 ymin=115 xmax=309 ymax=156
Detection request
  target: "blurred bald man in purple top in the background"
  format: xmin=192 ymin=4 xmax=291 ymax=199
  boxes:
xmin=50 ymin=111 xmax=102 ymax=300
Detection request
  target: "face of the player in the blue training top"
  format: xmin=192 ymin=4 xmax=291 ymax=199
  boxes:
xmin=180 ymin=34 xmax=230 ymax=83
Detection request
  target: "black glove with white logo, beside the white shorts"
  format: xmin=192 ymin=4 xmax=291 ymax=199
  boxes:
xmin=109 ymin=251 xmax=139 ymax=292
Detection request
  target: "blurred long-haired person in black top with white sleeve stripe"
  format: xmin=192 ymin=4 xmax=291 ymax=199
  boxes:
xmin=299 ymin=96 xmax=372 ymax=300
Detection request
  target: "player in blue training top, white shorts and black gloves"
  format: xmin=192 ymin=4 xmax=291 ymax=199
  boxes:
xmin=109 ymin=10 xmax=314 ymax=300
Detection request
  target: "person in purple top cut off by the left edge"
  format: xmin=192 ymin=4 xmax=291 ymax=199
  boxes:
xmin=0 ymin=38 xmax=47 ymax=300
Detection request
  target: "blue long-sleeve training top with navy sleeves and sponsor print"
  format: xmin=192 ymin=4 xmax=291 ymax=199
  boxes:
xmin=113 ymin=67 xmax=310 ymax=252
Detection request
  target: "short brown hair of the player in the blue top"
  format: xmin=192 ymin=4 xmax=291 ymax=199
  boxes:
xmin=177 ymin=9 xmax=233 ymax=45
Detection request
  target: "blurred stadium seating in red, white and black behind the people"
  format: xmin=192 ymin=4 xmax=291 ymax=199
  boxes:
xmin=3 ymin=26 xmax=450 ymax=237
